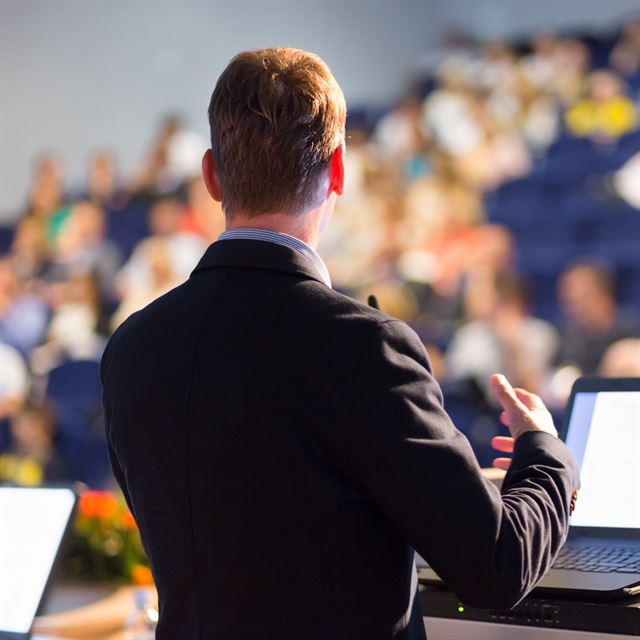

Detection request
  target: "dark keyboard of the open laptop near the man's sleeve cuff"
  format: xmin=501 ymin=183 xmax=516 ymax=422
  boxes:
xmin=553 ymin=544 xmax=640 ymax=573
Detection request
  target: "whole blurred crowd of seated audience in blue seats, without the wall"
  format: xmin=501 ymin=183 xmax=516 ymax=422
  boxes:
xmin=0 ymin=19 xmax=640 ymax=485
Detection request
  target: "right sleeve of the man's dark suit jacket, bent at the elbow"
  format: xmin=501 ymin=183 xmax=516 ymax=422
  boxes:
xmin=349 ymin=320 xmax=578 ymax=608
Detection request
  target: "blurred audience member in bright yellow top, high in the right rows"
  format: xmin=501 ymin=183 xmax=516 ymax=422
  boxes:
xmin=565 ymin=71 xmax=638 ymax=140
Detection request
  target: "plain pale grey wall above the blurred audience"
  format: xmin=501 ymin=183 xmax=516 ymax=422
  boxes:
xmin=0 ymin=0 xmax=638 ymax=219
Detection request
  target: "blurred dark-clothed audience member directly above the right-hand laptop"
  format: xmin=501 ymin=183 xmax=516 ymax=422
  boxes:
xmin=557 ymin=262 xmax=640 ymax=375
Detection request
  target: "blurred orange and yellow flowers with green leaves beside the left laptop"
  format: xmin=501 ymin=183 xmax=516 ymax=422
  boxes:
xmin=64 ymin=491 xmax=153 ymax=585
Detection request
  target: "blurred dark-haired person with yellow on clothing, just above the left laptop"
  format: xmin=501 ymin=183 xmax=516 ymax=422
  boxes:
xmin=0 ymin=404 xmax=65 ymax=486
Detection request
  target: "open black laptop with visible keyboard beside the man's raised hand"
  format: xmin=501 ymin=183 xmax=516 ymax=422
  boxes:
xmin=418 ymin=378 xmax=640 ymax=600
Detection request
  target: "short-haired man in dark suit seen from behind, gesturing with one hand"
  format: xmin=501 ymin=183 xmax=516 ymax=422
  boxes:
xmin=102 ymin=49 xmax=578 ymax=640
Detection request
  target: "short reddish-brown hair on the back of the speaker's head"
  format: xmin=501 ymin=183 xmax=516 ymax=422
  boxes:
xmin=209 ymin=48 xmax=346 ymax=216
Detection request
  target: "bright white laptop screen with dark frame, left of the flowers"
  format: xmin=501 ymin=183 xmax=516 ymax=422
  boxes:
xmin=0 ymin=486 xmax=77 ymax=640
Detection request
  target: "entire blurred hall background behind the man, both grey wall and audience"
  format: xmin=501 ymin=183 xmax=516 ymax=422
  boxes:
xmin=0 ymin=0 xmax=640 ymax=496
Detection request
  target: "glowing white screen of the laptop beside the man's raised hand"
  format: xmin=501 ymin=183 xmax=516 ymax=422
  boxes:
xmin=566 ymin=391 xmax=640 ymax=530
